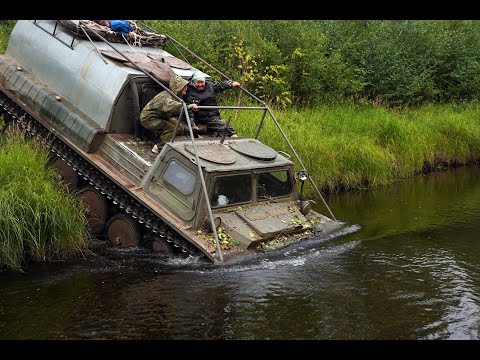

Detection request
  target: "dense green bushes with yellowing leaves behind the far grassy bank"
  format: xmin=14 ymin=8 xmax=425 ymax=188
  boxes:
xmin=136 ymin=20 xmax=480 ymax=106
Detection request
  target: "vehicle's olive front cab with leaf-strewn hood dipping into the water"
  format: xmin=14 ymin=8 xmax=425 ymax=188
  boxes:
xmin=144 ymin=138 xmax=342 ymax=259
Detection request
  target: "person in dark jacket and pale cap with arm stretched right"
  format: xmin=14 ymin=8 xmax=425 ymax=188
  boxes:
xmin=184 ymin=71 xmax=240 ymax=137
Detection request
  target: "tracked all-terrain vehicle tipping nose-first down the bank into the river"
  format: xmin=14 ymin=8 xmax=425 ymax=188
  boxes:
xmin=0 ymin=20 xmax=342 ymax=261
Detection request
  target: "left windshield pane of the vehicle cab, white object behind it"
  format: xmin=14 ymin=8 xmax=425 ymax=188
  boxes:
xmin=210 ymin=174 xmax=252 ymax=207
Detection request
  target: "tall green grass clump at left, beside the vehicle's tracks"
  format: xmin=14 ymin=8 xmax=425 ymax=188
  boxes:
xmin=0 ymin=136 xmax=88 ymax=271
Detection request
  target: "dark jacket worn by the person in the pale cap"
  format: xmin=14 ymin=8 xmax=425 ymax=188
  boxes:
xmin=185 ymin=80 xmax=232 ymax=123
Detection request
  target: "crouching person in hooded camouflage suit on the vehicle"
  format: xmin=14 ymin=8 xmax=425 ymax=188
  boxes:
xmin=140 ymin=74 xmax=198 ymax=153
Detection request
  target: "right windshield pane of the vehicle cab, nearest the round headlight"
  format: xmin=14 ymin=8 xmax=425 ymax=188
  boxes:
xmin=257 ymin=170 xmax=293 ymax=200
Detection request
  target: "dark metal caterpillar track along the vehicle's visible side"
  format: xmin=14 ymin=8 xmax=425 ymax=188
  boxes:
xmin=0 ymin=92 xmax=205 ymax=258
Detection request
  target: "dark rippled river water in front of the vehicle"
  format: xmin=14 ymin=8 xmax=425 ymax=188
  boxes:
xmin=0 ymin=167 xmax=480 ymax=340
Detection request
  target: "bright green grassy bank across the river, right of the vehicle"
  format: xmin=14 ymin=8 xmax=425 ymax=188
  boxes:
xmin=227 ymin=102 xmax=480 ymax=192
